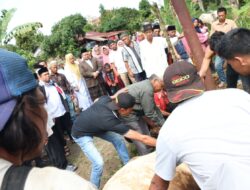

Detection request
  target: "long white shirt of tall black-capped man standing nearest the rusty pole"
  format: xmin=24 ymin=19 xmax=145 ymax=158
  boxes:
xmin=140 ymin=37 xmax=168 ymax=78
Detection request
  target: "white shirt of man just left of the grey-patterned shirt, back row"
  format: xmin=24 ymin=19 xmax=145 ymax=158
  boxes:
xmin=109 ymin=47 xmax=127 ymax=74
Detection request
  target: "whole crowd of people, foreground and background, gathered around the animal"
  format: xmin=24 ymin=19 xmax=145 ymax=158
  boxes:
xmin=0 ymin=5 xmax=250 ymax=190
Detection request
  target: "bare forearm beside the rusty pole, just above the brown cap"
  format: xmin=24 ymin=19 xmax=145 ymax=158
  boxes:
xmin=198 ymin=46 xmax=215 ymax=78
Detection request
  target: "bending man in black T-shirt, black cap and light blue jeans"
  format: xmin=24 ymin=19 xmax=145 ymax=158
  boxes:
xmin=72 ymin=90 xmax=156 ymax=188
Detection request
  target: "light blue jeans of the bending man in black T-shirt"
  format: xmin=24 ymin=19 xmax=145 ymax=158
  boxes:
xmin=73 ymin=132 xmax=130 ymax=188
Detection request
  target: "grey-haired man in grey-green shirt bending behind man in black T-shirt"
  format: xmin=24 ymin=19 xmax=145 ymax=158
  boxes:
xmin=122 ymin=75 xmax=165 ymax=155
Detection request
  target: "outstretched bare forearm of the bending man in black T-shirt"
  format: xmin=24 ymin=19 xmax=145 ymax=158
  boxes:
xmin=124 ymin=129 xmax=156 ymax=146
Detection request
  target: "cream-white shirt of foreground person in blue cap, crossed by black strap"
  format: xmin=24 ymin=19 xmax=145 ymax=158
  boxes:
xmin=0 ymin=159 xmax=96 ymax=190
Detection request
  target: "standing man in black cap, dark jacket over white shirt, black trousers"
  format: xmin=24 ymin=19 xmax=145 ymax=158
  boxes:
xmin=37 ymin=67 xmax=77 ymax=171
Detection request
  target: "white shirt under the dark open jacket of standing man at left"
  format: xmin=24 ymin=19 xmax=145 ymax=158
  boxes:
xmin=39 ymin=81 xmax=66 ymax=118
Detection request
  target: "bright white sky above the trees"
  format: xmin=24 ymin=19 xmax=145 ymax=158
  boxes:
xmin=0 ymin=0 xmax=161 ymax=34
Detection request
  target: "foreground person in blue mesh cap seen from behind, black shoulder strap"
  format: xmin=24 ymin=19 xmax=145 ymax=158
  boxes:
xmin=0 ymin=49 xmax=95 ymax=190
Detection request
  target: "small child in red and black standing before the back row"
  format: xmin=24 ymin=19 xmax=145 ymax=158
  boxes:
xmin=104 ymin=63 xmax=124 ymax=95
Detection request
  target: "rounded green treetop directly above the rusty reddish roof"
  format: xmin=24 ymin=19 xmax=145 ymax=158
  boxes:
xmin=99 ymin=7 xmax=141 ymax=32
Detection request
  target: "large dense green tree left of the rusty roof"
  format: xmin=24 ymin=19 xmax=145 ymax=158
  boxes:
xmin=42 ymin=14 xmax=87 ymax=57
